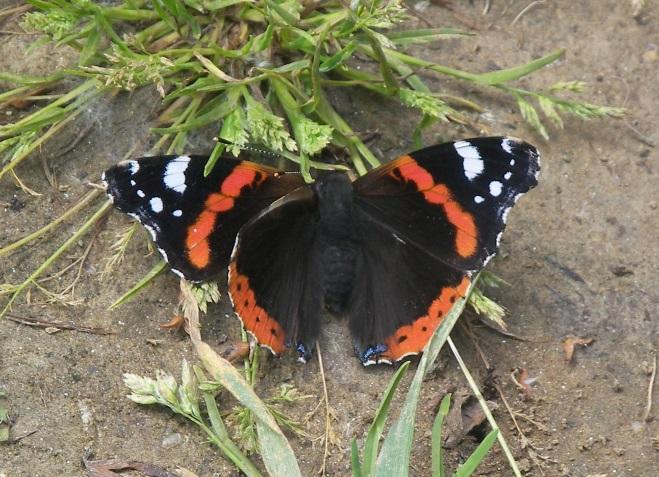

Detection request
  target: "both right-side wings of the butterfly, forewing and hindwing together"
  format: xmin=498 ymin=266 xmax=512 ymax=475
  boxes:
xmin=349 ymin=137 xmax=539 ymax=364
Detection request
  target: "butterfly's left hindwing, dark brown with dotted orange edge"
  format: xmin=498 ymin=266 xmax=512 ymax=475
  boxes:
xmin=229 ymin=187 xmax=322 ymax=361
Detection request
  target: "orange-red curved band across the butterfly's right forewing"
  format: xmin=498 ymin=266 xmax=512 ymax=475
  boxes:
xmin=396 ymin=156 xmax=478 ymax=258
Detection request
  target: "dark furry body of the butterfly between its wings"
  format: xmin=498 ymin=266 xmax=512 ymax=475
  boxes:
xmin=313 ymin=172 xmax=357 ymax=314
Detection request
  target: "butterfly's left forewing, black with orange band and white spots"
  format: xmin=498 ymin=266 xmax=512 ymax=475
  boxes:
xmin=103 ymin=156 xmax=304 ymax=281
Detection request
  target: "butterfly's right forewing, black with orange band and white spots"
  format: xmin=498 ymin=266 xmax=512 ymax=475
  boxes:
xmin=354 ymin=137 xmax=539 ymax=270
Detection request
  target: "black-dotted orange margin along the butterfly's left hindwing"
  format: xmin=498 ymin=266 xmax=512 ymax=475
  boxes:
xmin=229 ymin=262 xmax=286 ymax=354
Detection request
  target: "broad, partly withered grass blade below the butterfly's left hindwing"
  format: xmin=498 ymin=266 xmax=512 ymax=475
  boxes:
xmin=195 ymin=342 xmax=302 ymax=477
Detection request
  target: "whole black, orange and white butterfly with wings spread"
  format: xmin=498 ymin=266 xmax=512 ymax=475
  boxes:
xmin=103 ymin=137 xmax=540 ymax=365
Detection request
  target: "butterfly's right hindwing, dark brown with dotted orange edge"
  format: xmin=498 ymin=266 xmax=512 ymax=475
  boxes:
xmin=348 ymin=206 xmax=470 ymax=365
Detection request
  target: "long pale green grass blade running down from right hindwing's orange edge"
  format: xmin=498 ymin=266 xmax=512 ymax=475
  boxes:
xmin=374 ymin=282 xmax=469 ymax=477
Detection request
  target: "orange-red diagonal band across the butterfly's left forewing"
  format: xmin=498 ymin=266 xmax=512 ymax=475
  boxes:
xmin=185 ymin=164 xmax=266 ymax=269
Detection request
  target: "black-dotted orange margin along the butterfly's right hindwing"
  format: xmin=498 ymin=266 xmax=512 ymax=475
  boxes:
xmin=380 ymin=277 xmax=471 ymax=361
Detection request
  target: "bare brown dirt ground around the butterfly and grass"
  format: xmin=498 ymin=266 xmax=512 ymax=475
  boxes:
xmin=0 ymin=0 xmax=659 ymax=477
